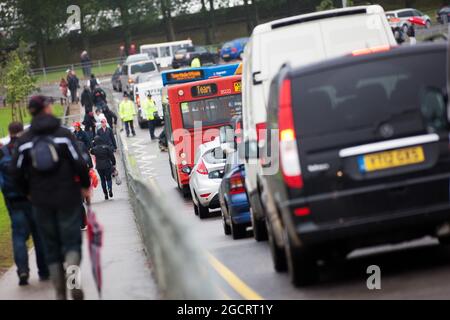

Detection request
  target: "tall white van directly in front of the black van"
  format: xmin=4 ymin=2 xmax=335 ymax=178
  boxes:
xmin=242 ymin=5 xmax=397 ymax=241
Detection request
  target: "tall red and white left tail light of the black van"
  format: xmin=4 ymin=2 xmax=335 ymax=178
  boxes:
xmin=278 ymin=79 xmax=303 ymax=189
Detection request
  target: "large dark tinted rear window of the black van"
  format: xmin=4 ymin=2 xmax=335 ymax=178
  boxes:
xmin=292 ymin=52 xmax=448 ymax=138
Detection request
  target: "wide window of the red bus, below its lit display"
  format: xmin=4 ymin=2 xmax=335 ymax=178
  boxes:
xmin=180 ymin=94 xmax=242 ymax=129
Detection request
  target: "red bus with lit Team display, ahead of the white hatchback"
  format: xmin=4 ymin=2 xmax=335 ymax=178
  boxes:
xmin=164 ymin=75 xmax=242 ymax=195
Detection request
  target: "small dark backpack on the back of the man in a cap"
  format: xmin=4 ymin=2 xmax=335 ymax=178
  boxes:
xmin=30 ymin=136 xmax=59 ymax=172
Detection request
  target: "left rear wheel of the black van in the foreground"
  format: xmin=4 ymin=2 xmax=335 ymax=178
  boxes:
xmin=284 ymin=226 xmax=319 ymax=287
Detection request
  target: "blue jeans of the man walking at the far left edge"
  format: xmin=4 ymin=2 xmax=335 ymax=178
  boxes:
xmin=6 ymin=200 xmax=49 ymax=277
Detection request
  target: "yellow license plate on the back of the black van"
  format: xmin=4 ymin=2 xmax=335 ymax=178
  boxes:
xmin=358 ymin=147 xmax=425 ymax=172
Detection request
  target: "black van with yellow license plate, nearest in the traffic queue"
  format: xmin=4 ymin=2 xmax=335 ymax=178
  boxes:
xmin=261 ymin=44 xmax=450 ymax=285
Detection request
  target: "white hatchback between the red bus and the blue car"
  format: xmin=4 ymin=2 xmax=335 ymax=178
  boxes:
xmin=188 ymin=139 xmax=226 ymax=219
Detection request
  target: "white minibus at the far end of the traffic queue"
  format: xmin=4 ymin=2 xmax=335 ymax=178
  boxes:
xmin=140 ymin=40 xmax=192 ymax=68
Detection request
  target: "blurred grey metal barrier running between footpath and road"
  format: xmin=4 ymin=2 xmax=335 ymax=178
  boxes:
xmin=117 ymin=134 xmax=224 ymax=299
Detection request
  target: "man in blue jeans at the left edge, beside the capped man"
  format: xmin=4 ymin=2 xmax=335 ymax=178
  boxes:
xmin=0 ymin=122 xmax=49 ymax=286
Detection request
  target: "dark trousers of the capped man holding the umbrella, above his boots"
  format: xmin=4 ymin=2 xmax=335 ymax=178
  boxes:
xmin=34 ymin=206 xmax=83 ymax=265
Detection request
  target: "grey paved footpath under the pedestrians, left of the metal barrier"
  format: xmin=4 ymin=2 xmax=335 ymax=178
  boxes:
xmin=0 ymin=151 xmax=159 ymax=300
